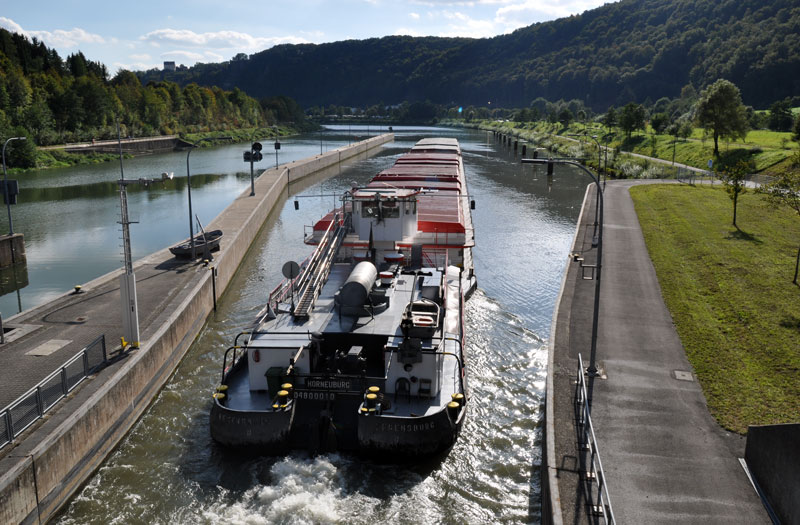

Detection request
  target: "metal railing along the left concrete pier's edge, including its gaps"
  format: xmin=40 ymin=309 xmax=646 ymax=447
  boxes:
xmin=0 ymin=335 xmax=108 ymax=448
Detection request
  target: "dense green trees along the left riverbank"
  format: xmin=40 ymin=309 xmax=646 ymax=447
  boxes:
xmin=0 ymin=29 xmax=310 ymax=168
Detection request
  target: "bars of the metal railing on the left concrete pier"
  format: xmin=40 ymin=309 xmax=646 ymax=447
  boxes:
xmin=0 ymin=334 xmax=109 ymax=448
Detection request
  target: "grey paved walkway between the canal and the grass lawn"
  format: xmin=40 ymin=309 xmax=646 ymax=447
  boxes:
xmin=548 ymin=181 xmax=770 ymax=524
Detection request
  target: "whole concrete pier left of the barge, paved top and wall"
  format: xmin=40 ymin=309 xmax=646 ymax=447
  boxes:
xmin=0 ymin=134 xmax=394 ymax=523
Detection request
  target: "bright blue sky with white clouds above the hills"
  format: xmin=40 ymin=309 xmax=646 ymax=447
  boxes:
xmin=0 ymin=0 xmax=609 ymax=74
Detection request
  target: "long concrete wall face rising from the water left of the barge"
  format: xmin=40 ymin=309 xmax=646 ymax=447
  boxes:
xmin=0 ymin=134 xmax=393 ymax=523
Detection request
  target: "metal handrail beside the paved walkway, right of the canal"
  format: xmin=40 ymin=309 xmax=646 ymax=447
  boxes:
xmin=575 ymin=354 xmax=616 ymax=524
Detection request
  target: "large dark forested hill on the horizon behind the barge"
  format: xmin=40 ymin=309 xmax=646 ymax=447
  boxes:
xmin=141 ymin=0 xmax=800 ymax=111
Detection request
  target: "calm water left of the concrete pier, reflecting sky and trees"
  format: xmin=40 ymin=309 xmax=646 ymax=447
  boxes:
xmin=0 ymin=133 xmax=360 ymax=317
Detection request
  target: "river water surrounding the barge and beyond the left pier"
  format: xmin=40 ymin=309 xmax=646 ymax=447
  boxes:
xmin=45 ymin=127 xmax=587 ymax=524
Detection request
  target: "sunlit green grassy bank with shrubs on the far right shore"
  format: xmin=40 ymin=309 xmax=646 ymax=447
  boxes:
xmin=456 ymin=96 xmax=800 ymax=177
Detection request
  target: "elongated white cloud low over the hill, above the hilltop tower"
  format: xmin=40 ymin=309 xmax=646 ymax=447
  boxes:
xmin=140 ymin=28 xmax=308 ymax=51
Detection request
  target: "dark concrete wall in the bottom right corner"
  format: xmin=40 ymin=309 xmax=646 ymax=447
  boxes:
xmin=744 ymin=423 xmax=800 ymax=524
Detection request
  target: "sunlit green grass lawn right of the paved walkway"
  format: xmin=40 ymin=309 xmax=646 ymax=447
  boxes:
xmin=631 ymin=185 xmax=800 ymax=434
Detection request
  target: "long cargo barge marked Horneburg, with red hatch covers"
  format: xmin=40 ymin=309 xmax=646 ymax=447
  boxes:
xmin=210 ymin=138 xmax=476 ymax=461
